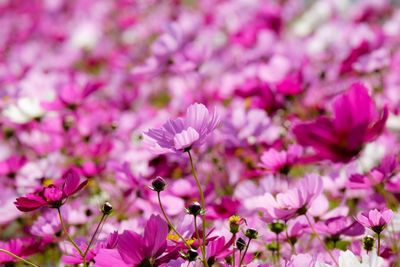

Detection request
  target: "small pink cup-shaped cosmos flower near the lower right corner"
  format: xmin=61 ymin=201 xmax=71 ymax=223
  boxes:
xmin=357 ymin=209 xmax=393 ymax=234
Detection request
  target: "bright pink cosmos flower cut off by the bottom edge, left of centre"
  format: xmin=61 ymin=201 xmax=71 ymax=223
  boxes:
xmin=95 ymin=215 xmax=178 ymax=267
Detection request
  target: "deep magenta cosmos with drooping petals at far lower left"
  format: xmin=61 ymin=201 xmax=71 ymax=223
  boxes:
xmin=14 ymin=169 xmax=88 ymax=212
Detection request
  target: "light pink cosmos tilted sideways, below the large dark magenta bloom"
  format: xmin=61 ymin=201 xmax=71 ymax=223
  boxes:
xmin=264 ymin=175 xmax=323 ymax=222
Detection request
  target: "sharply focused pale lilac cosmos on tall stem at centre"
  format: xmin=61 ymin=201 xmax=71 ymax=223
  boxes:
xmin=144 ymin=103 xmax=219 ymax=154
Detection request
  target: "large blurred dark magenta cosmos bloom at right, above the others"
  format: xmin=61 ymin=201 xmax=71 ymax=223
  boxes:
xmin=293 ymin=84 xmax=388 ymax=162
